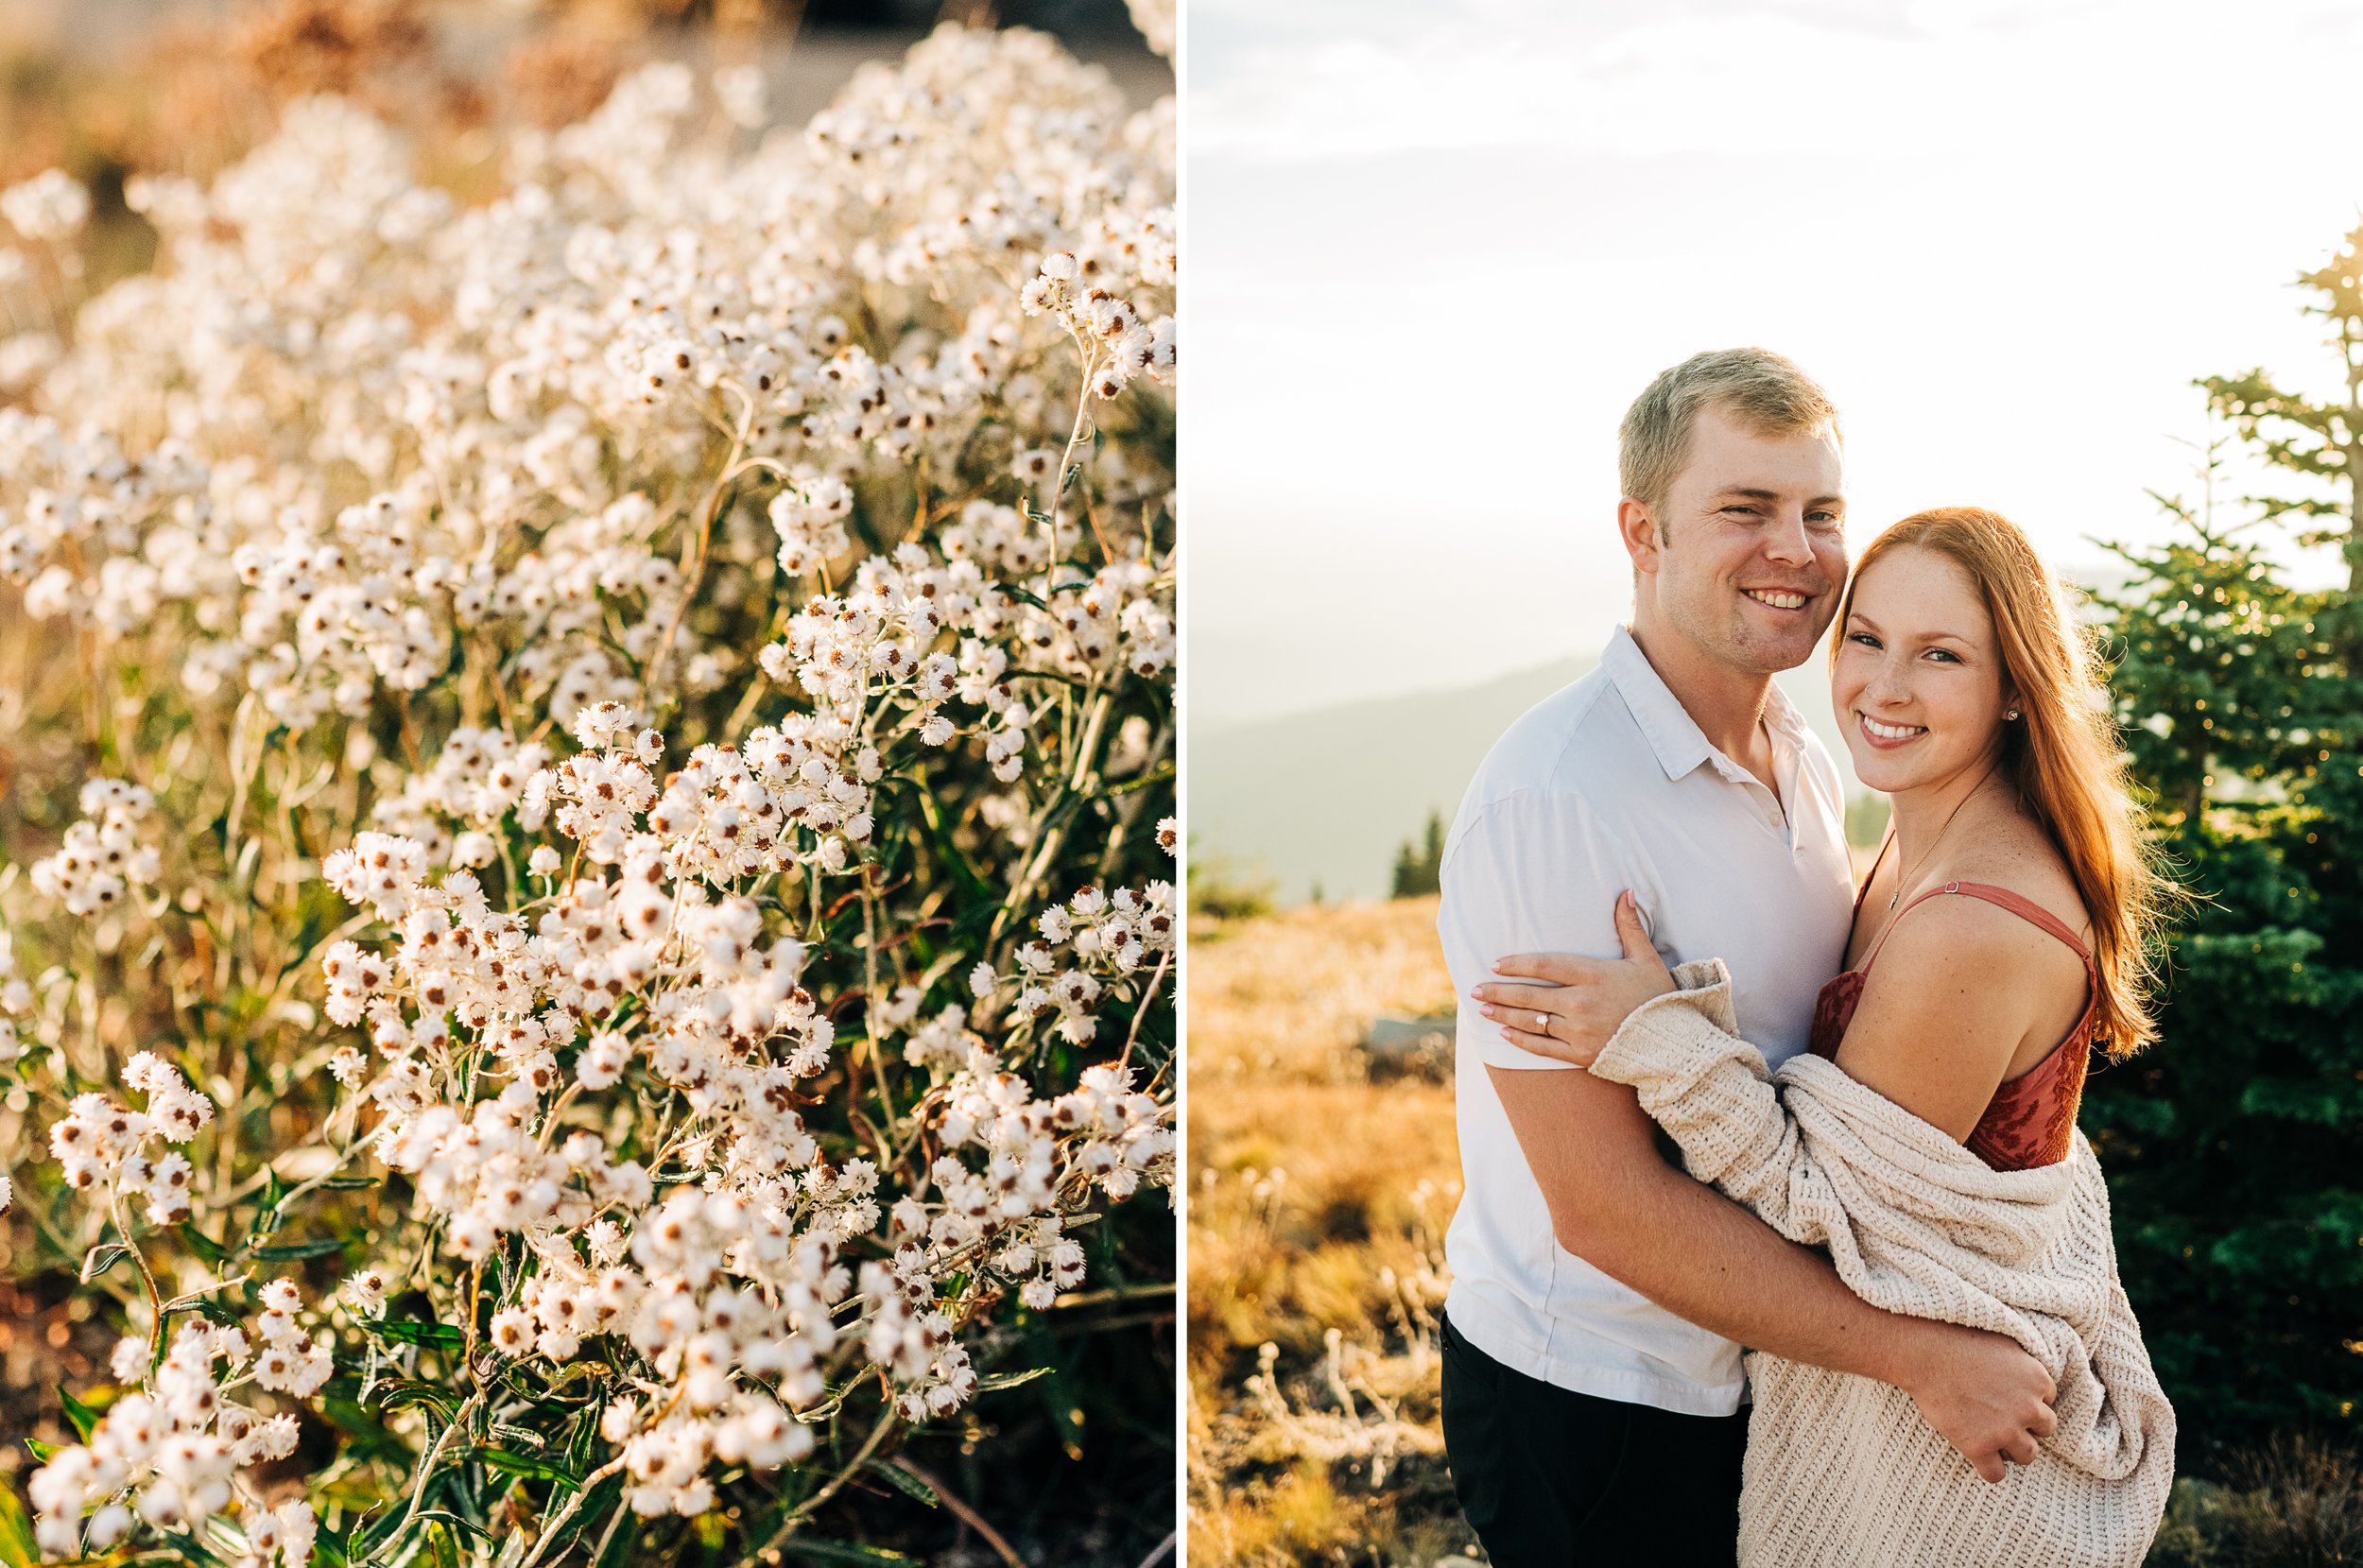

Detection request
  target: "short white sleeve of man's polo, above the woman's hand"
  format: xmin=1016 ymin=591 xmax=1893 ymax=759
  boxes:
xmin=1437 ymin=791 xmax=1635 ymax=1072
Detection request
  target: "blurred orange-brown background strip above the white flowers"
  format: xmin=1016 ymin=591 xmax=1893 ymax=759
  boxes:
xmin=0 ymin=0 xmax=1172 ymax=311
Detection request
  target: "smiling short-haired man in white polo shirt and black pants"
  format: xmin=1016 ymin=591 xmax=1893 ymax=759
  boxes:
xmin=1437 ymin=350 xmax=2054 ymax=1568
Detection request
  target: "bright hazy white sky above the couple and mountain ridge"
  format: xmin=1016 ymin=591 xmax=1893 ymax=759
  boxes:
xmin=1184 ymin=0 xmax=2363 ymax=725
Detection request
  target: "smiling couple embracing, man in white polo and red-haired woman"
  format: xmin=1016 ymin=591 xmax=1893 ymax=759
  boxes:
xmin=1440 ymin=350 xmax=2174 ymax=1568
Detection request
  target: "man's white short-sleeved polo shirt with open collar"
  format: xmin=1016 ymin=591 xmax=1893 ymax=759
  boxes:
xmin=1437 ymin=626 xmax=1853 ymax=1415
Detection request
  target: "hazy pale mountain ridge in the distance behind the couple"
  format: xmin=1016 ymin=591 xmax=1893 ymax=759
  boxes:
xmin=1189 ymin=659 xmax=1855 ymax=905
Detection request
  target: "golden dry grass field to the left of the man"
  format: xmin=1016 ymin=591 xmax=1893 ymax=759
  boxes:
xmin=1189 ymin=897 xmax=1475 ymax=1568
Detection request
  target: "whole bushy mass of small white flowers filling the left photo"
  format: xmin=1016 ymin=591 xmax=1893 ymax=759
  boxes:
xmin=0 ymin=15 xmax=1180 ymax=1568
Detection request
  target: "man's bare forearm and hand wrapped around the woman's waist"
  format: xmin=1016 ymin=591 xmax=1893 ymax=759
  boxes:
xmin=1487 ymin=1065 xmax=2056 ymax=1481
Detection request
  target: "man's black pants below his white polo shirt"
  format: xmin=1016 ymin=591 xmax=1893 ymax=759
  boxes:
xmin=1444 ymin=1320 xmax=1749 ymax=1568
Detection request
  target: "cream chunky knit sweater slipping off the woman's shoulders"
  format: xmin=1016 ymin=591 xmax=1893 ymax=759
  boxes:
xmin=1593 ymin=958 xmax=2174 ymax=1568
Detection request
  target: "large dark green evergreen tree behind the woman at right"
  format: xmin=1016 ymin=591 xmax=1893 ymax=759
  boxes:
xmin=2084 ymin=229 xmax=2363 ymax=1469
